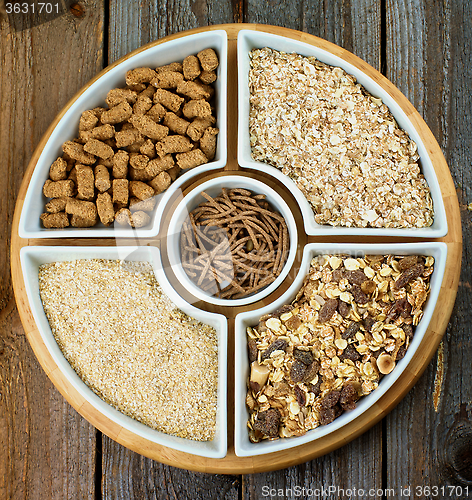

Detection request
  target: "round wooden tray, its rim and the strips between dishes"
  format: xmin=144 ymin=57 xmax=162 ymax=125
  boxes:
xmin=11 ymin=24 xmax=462 ymax=474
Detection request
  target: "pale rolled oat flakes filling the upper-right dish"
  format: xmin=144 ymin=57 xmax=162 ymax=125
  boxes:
xmin=249 ymin=48 xmax=434 ymax=228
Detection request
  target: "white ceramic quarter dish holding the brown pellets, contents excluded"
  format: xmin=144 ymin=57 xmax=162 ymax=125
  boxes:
xmin=19 ymin=30 xmax=228 ymax=238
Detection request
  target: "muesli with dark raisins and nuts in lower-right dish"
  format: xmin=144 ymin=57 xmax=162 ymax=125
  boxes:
xmin=246 ymin=255 xmax=434 ymax=443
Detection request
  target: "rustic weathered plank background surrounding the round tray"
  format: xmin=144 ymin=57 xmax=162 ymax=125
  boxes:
xmin=0 ymin=0 xmax=472 ymax=500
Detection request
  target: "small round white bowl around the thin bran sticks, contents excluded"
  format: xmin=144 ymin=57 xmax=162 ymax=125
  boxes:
xmin=167 ymin=174 xmax=298 ymax=307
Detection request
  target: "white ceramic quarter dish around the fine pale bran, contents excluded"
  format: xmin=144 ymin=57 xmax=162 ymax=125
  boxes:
xmin=20 ymin=246 xmax=228 ymax=458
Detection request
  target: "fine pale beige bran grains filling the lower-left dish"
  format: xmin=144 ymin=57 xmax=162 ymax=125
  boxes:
xmin=39 ymin=259 xmax=218 ymax=441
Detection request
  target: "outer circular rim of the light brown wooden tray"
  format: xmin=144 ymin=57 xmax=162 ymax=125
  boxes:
xmin=11 ymin=24 xmax=462 ymax=474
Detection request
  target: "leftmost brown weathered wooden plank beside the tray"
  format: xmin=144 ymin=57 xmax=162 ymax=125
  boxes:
xmin=0 ymin=0 xmax=103 ymax=499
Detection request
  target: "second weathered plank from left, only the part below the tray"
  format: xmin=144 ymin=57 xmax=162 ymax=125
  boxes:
xmin=102 ymin=439 xmax=240 ymax=500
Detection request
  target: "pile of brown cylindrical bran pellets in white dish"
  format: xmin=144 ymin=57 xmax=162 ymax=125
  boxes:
xmin=41 ymin=48 xmax=218 ymax=229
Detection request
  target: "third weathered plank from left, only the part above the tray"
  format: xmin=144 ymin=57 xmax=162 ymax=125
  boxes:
xmin=244 ymin=0 xmax=381 ymax=69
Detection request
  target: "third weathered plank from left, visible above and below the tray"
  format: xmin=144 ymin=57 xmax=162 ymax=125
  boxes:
xmin=243 ymin=0 xmax=382 ymax=499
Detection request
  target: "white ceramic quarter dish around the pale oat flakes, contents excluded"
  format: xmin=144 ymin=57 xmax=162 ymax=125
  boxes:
xmin=238 ymin=30 xmax=447 ymax=238
